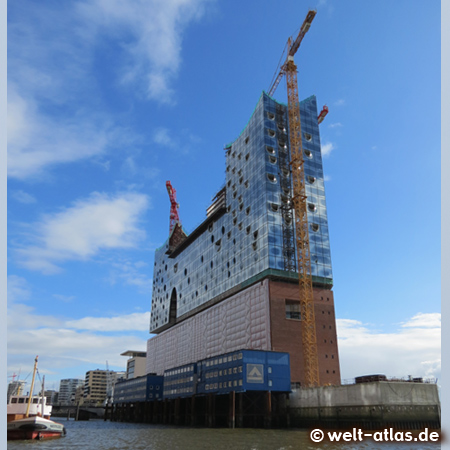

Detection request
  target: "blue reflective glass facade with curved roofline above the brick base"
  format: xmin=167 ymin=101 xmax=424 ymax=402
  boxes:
xmin=150 ymin=93 xmax=332 ymax=332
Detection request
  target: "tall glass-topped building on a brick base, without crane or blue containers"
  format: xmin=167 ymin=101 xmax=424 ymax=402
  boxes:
xmin=146 ymin=93 xmax=340 ymax=386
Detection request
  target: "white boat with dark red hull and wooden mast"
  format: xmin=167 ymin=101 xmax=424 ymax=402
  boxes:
xmin=7 ymin=356 xmax=66 ymax=440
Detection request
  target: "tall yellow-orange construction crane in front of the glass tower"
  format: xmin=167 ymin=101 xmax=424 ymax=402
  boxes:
xmin=268 ymin=10 xmax=320 ymax=386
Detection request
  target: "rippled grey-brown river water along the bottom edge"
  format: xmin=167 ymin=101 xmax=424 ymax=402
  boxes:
xmin=7 ymin=418 xmax=440 ymax=450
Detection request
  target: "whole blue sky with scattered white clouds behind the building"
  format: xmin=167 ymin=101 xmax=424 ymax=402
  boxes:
xmin=7 ymin=0 xmax=441 ymax=390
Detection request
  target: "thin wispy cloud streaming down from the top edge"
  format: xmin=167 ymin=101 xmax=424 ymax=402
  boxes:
xmin=79 ymin=0 xmax=211 ymax=103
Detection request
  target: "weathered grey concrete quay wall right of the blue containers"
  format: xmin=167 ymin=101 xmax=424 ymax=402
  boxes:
xmin=289 ymin=381 xmax=441 ymax=429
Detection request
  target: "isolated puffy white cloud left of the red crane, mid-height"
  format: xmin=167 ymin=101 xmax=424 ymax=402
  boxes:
xmin=16 ymin=192 xmax=149 ymax=273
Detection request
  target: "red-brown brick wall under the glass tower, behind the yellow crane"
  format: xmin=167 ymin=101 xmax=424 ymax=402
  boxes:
xmin=269 ymin=281 xmax=341 ymax=385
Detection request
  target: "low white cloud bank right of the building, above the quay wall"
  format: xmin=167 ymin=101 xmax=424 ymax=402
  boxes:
xmin=337 ymin=313 xmax=441 ymax=379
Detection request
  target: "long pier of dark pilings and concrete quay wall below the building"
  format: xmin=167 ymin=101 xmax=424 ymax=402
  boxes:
xmin=110 ymin=381 xmax=441 ymax=430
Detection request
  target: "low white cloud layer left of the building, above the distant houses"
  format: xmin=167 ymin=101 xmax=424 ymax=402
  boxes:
xmin=8 ymin=304 xmax=150 ymax=378
